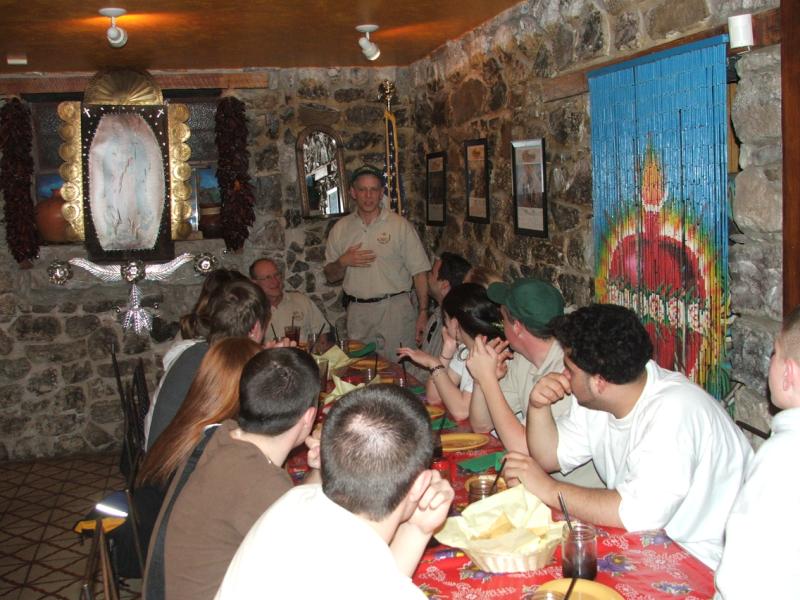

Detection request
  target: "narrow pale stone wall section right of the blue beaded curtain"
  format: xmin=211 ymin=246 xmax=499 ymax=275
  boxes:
xmin=730 ymin=46 xmax=783 ymax=441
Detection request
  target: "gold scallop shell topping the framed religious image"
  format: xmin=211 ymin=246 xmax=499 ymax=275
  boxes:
xmin=83 ymin=69 xmax=163 ymax=105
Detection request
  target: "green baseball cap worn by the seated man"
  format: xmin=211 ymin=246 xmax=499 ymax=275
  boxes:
xmin=487 ymin=277 xmax=564 ymax=331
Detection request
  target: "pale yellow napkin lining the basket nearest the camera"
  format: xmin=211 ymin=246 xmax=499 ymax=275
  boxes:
xmin=436 ymin=485 xmax=564 ymax=555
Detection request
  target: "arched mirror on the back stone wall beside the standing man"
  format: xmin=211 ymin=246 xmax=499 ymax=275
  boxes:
xmin=297 ymin=125 xmax=347 ymax=217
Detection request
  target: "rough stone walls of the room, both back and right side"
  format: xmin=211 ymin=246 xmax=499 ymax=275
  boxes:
xmin=0 ymin=0 xmax=781 ymax=460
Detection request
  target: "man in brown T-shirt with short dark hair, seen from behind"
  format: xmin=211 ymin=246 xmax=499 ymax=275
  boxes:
xmin=144 ymin=348 xmax=319 ymax=600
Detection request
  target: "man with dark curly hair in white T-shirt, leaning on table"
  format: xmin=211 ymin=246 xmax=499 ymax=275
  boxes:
xmin=505 ymin=304 xmax=752 ymax=569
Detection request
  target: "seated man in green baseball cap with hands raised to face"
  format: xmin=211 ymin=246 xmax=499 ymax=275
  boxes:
xmin=467 ymin=277 xmax=603 ymax=487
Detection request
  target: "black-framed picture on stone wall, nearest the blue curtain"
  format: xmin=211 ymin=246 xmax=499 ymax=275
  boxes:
xmin=511 ymin=138 xmax=547 ymax=238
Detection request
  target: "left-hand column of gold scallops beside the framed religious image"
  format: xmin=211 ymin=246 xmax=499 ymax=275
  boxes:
xmin=58 ymin=102 xmax=85 ymax=241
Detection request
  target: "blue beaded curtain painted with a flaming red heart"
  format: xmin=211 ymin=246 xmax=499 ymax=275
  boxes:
xmin=589 ymin=36 xmax=729 ymax=398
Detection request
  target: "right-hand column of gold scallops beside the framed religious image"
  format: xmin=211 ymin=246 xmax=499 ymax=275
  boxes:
xmin=167 ymin=104 xmax=192 ymax=240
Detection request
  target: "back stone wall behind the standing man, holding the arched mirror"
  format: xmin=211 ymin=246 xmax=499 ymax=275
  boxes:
xmin=0 ymin=68 xmax=412 ymax=460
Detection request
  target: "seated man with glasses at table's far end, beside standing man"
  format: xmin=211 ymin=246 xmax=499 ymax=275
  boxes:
xmin=250 ymin=258 xmax=327 ymax=342
